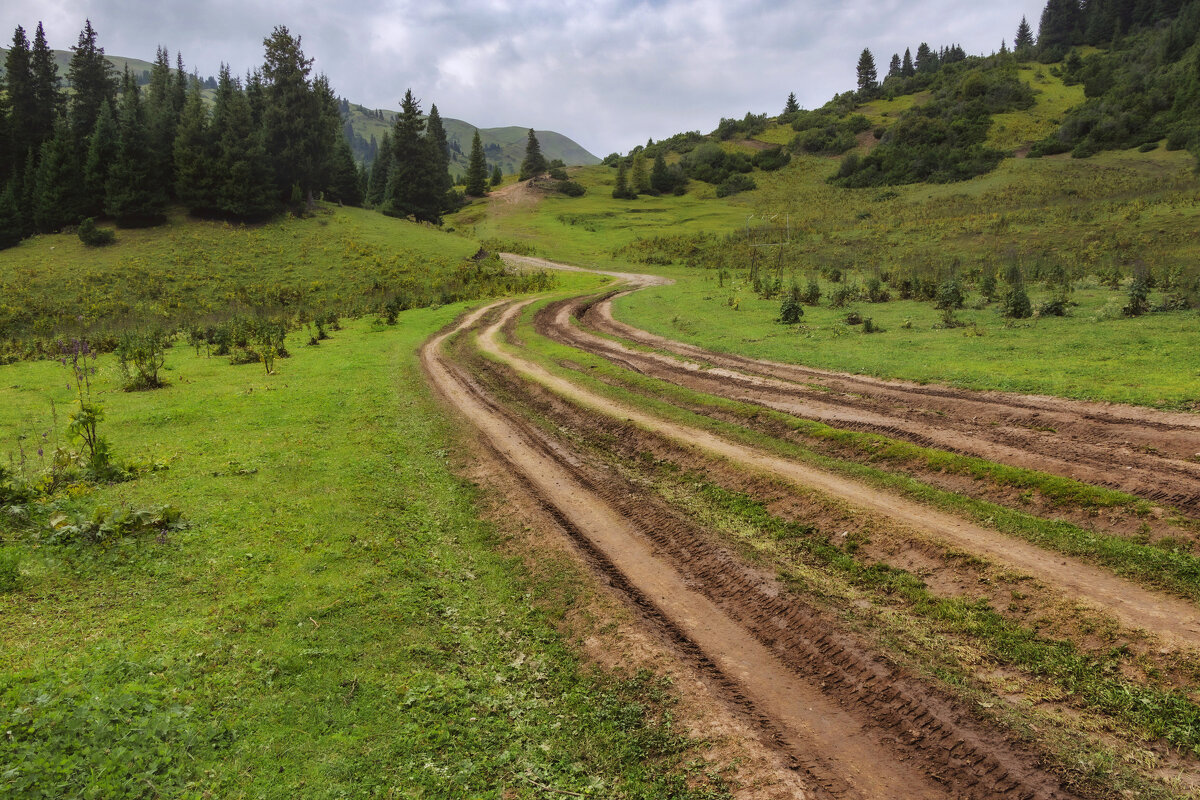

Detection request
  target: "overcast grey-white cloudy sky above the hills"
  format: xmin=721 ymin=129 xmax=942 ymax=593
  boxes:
xmin=0 ymin=0 xmax=1045 ymax=156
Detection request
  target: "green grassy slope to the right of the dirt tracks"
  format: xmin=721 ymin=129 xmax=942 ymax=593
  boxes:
xmin=455 ymin=77 xmax=1200 ymax=408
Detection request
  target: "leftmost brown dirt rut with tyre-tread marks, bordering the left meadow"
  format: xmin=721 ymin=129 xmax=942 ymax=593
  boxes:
xmin=421 ymin=303 xmax=1072 ymax=800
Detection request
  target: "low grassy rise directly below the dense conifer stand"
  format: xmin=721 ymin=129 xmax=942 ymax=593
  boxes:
xmin=0 ymin=207 xmax=478 ymax=341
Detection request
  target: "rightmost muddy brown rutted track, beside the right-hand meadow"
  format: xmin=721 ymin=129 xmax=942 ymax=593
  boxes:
xmin=564 ymin=292 xmax=1200 ymax=516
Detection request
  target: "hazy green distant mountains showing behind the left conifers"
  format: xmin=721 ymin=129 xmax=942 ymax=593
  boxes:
xmin=0 ymin=48 xmax=600 ymax=175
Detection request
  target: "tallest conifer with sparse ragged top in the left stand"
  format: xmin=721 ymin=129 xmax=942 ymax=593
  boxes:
xmin=263 ymin=25 xmax=328 ymax=206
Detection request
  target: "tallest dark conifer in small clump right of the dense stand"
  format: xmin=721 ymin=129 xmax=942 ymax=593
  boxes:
xmin=383 ymin=89 xmax=443 ymax=224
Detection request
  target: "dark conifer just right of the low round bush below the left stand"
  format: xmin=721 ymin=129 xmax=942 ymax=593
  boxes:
xmin=104 ymin=71 xmax=167 ymax=228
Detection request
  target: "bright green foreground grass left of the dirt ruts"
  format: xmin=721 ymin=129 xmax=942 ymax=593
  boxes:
xmin=0 ymin=302 xmax=720 ymax=798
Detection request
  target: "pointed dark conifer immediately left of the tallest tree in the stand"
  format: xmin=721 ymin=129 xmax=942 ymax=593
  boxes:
xmin=211 ymin=64 xmax=278 ymax=219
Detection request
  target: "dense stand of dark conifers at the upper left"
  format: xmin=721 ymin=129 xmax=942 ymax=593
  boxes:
xmin=0 ymin=20 xmax=361 ymax=246
